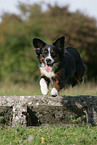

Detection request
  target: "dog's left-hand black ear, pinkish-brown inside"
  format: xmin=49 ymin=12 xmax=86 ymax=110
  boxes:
xmin=33 ymin=38 xmax=46 ymax=50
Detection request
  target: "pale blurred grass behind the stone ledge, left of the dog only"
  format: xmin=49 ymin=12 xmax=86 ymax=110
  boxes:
xmin=0 ymin=82 xmax=41 ymax=96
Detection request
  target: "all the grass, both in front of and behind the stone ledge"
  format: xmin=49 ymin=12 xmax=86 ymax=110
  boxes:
xmin=0 ymin=83 xmax=97 ymax=145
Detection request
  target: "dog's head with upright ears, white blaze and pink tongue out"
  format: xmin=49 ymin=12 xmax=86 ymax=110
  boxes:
xmin=33 ymin=36 xmax=65 ymax=72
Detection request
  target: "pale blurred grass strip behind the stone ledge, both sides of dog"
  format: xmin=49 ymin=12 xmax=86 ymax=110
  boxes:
xmin=0 ymin=82 xmax=97 ymax=96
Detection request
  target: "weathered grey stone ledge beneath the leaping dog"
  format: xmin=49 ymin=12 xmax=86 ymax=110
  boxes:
xmin=0 ymin=96 xmax=97 ymax=126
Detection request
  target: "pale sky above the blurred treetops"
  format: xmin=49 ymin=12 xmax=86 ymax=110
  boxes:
xmin=0 ymin=0 xmax=97 ymax=20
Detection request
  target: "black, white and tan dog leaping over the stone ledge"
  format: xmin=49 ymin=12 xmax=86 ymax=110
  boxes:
xmin=33 ymin=36 xmax=86 ymax=96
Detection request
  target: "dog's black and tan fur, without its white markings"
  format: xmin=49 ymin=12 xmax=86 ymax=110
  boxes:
xmin=33 ymin=36 xmax=86 ymax=95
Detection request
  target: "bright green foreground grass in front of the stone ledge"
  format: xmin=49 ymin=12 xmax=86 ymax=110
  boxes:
xmin=0 ymin=126 xmax=97 ymax=145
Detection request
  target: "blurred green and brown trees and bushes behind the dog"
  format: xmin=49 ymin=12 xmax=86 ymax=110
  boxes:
xmin=0 ymin=2 xmax=97 ymax=82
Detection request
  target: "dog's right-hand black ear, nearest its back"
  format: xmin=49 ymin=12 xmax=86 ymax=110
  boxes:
xmin=52 ymin=36 xmax=65 ymax=51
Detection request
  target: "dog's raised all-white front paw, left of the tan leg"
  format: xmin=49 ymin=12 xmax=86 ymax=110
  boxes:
xmin=40 ymin=78 xmax=48 ymax=95
